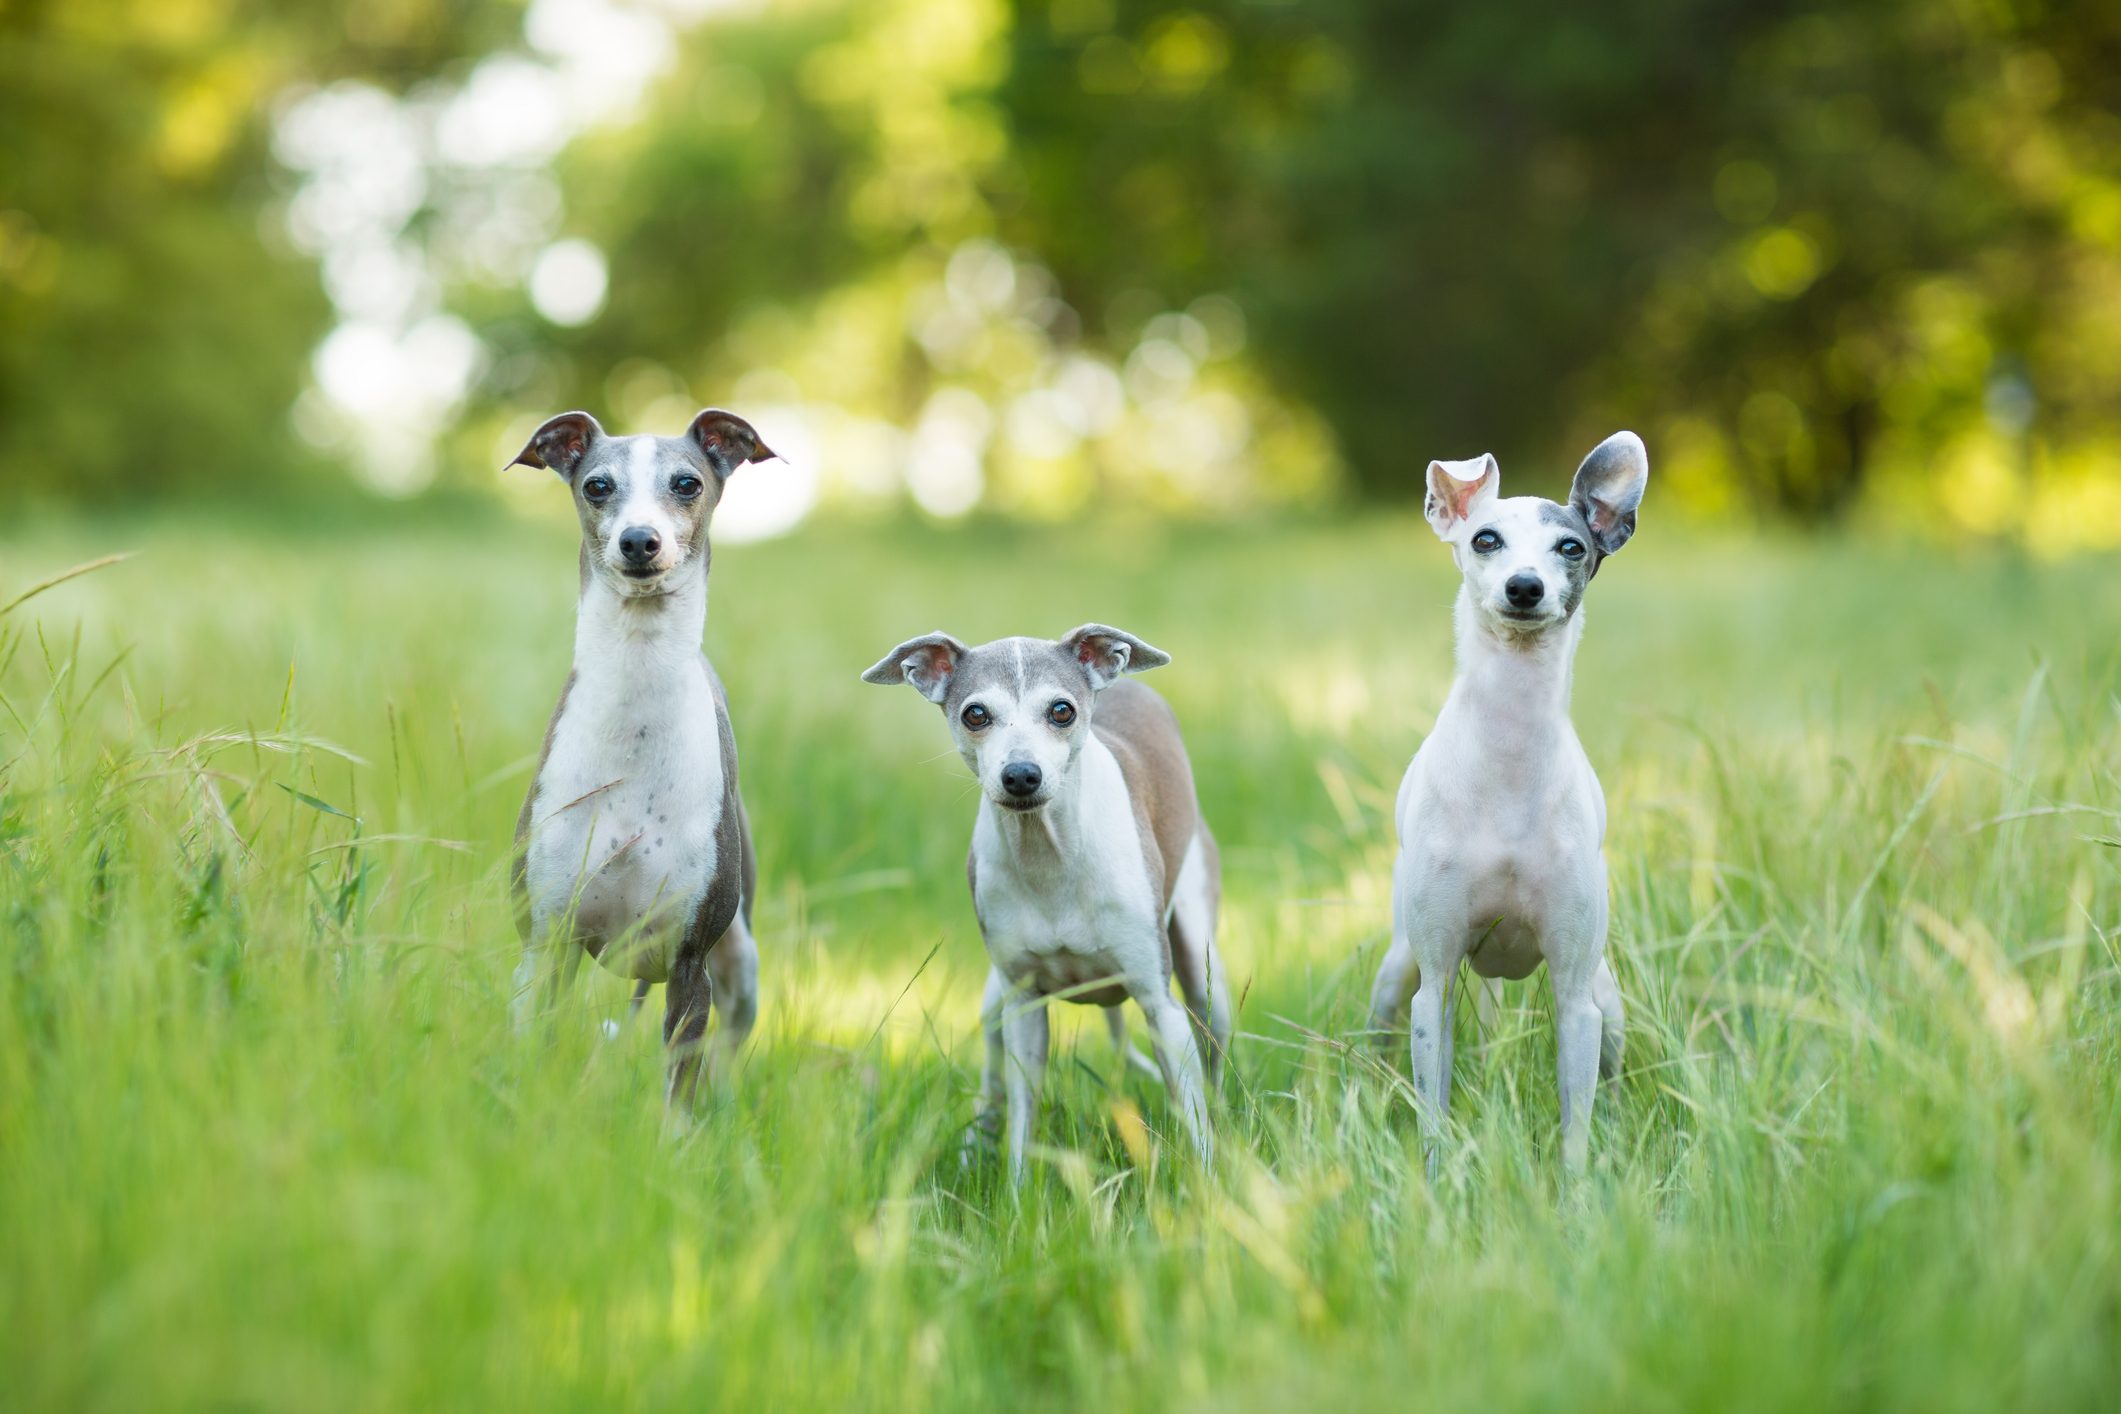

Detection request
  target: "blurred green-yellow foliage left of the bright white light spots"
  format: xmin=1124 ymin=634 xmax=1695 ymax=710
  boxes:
xmin=0 ymin=0 xmax=518 ymax=498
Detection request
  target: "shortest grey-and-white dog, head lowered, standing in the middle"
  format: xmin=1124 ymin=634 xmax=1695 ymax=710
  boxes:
xmin=861 ymin=623 xmax=1230 ymax=1185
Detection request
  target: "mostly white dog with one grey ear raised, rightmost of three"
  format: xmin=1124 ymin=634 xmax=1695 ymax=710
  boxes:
xmin=1370 ymin=432 xmax=1650 ymax=1172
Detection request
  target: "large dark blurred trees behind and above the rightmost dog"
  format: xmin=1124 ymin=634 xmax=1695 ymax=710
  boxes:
xmin=997 ymin=0 xmax=2121 ymax=524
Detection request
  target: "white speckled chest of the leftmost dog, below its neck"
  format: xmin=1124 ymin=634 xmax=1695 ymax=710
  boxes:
xmin=526 ymin=657 xmax=723 ymax=979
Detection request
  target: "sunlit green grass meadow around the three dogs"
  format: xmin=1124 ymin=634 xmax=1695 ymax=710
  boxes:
xmin=0 ymin=510 xmax=2121 ymax=1414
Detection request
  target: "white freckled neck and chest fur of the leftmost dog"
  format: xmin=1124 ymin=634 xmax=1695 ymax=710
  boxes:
xmin=526 ymin=572 xmax=723 ymax=982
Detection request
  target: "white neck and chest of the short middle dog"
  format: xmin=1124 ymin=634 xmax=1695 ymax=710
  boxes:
xmin=971 ymin=742 xmax=1164 ymax=1001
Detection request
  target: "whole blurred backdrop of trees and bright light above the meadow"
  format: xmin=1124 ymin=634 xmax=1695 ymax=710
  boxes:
xmin=0 ymin=0 xmax=2121 ymax=553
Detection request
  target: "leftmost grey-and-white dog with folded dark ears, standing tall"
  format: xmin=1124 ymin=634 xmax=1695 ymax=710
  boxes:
xmin=511 ymin=409 xmax=774 ymax=1102
